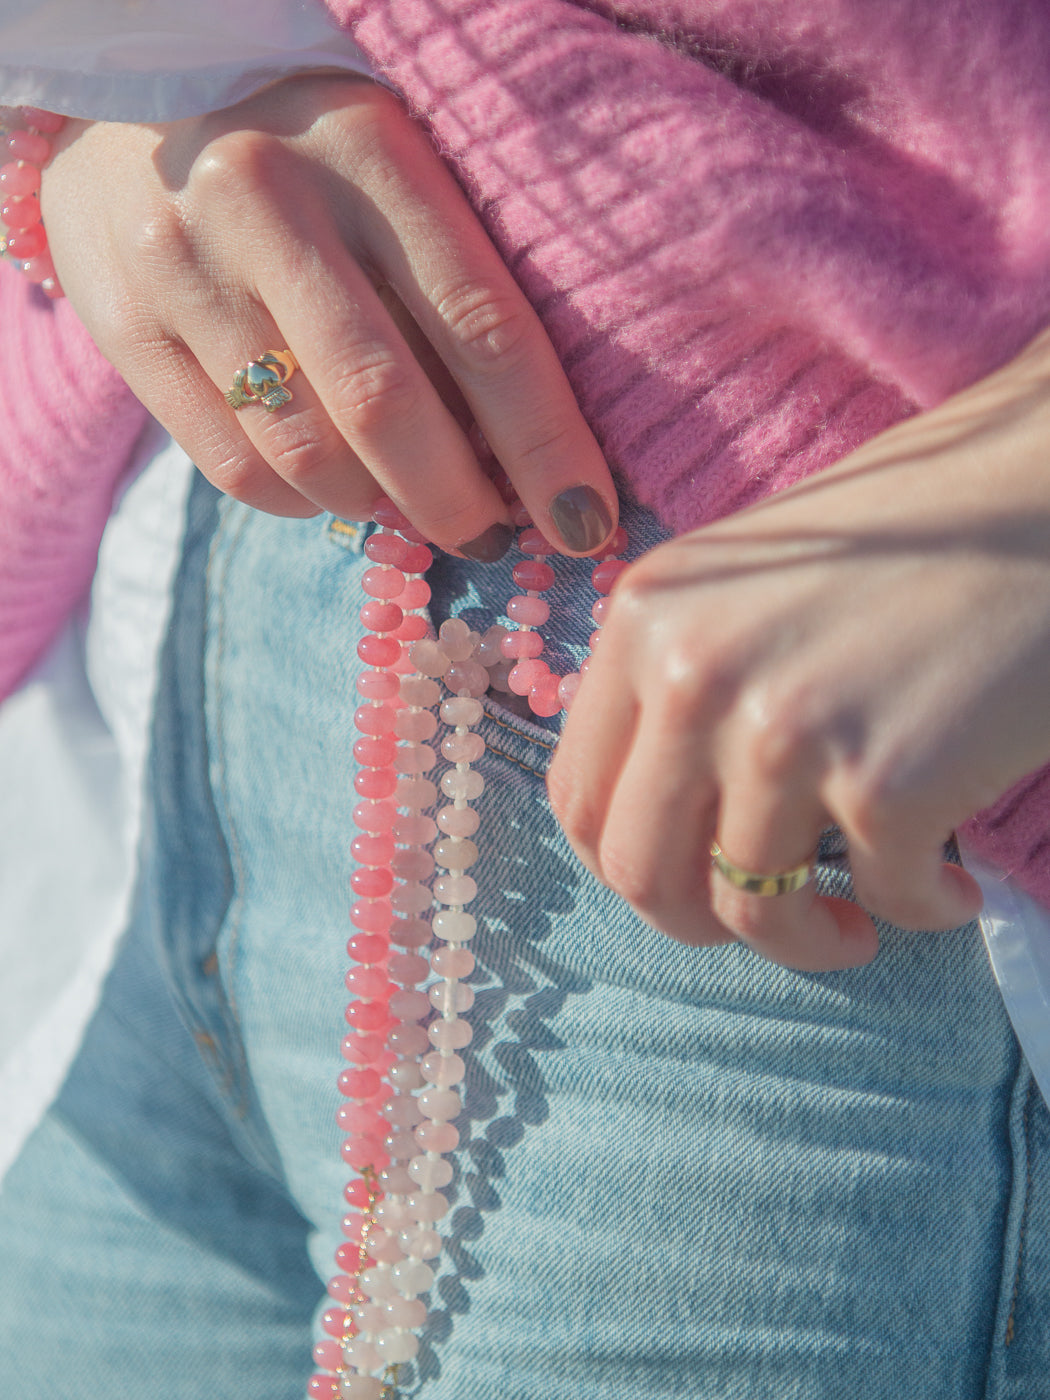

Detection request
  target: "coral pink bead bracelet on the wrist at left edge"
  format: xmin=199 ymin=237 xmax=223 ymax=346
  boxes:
xmin=0 ymin=106 xmax=66 ymax=298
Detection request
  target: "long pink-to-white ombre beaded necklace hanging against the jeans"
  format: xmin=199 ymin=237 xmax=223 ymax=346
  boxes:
xmin=308 ymin=501 xmax=627 ymax=1400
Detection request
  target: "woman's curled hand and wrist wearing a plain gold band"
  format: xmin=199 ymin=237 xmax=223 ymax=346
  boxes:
xmin=550 ymin=326 xmax=1050 ymax=969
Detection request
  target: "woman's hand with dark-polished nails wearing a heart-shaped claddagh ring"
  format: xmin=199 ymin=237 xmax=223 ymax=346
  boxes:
xmin=43 ymin=74 xmax=616 ymax=557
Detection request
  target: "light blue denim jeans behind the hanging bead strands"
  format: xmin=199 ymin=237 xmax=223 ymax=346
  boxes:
xmin=0 ymin=483 xmax=1050 ymax=1400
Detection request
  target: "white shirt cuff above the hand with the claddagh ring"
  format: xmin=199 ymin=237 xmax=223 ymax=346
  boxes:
xmin=0 ymin=0 xmax=370 ymax=122
